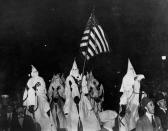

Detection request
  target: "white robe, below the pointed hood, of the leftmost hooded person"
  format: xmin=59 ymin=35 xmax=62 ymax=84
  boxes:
xmin=24 ymin=76 xmax=56 ymax=131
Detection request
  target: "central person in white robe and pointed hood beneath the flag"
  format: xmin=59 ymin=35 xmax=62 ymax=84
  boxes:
xmin=64 ymin=61 xmax=100 ymax=131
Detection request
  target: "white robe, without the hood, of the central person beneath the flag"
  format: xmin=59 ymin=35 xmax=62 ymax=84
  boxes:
xmin=64 ymin=72 xmax=100 ymax=131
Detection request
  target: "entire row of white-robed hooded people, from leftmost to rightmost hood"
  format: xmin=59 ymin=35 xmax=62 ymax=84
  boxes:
xmin=23 ymin=60 xmax=167 ymax=131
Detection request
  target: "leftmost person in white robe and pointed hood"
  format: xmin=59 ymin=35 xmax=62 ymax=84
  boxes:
xmin=23 ymin=65 xmax=56 ymax=131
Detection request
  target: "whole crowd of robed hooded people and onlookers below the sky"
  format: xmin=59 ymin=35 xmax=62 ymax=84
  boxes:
xmin=0 ymin=60 xmax=168 ymax=131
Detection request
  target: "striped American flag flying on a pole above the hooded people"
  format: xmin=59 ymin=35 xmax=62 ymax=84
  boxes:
xmin=80 ymin=12 xmax=110 ymax=60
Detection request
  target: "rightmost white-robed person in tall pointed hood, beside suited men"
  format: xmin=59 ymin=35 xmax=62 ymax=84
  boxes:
xmin=119 ymin=59 xmax=144 ymax=131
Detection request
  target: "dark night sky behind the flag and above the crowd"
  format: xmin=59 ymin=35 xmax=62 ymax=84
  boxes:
xmin=0 ymin=0 xmax=168 ymax=108
